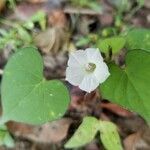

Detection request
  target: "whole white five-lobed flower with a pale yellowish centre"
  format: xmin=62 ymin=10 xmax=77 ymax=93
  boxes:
xmin=66 ymin=48 xmax=110 ymax=93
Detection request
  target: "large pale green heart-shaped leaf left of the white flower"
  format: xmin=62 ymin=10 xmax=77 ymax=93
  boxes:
xmin=1 ymin=47 xmax=69 ymax=124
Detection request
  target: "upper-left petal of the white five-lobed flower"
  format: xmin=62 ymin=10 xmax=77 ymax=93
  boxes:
xmin=68 ymin=50 xmax=87 ymax=67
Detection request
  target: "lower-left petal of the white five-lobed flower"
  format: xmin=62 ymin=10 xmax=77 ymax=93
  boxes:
xmin=66 ymin=67 xmax=84 ymax=86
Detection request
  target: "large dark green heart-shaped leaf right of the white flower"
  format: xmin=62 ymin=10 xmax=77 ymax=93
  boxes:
xmin=100 ymin=50 xmax=150 ymax=122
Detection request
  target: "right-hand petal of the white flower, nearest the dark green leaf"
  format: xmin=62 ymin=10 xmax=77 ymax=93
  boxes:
xmin=94 ymin=62 xmax=110 ymax=83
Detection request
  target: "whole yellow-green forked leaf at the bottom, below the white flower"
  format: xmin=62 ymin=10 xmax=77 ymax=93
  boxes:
xmin=65 ymin=117 xmax=122 ymax=150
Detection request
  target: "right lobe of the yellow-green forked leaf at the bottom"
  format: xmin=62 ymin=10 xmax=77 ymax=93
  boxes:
xmin=99 ymin=121 xmax=122 ymax=150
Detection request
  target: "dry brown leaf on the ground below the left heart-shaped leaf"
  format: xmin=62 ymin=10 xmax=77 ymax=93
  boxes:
xmin=8 ymin=118 xmax=72 ymax=143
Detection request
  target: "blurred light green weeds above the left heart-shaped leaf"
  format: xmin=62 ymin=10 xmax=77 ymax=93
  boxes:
xmin=0 ymin=11 xmax=46 ymax=50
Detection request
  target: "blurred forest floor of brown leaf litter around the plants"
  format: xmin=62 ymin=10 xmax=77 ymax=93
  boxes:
xmin=0 ymin=0 xmax=150 ymax=150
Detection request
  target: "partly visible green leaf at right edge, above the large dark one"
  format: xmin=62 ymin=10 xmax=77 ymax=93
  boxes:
xmin=126 ymin=28 xmax=150 ymax=51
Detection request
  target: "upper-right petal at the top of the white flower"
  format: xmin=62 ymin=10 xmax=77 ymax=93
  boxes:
xmin=85 ymin=48 xmax=103 ymax=63
